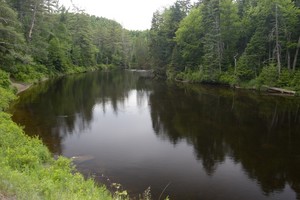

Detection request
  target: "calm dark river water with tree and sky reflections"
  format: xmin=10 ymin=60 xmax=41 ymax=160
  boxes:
xmin=11 ymin=72 xmax=300 ymax=200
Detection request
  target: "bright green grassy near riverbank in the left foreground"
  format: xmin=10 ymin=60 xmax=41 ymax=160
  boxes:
xmin=0 ymin=68 xmax=126 ymax=200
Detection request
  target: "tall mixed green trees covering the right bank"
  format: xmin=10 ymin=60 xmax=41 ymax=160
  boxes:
xmin=149 ymin=0 xmax=300 ymax=90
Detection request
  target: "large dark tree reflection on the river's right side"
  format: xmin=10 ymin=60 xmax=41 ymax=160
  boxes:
xmin=150 ymin=84 xmax=300 ymax=199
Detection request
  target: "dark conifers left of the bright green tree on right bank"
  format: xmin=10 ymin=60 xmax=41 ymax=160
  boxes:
xmin=149 ymin=0 xmax=190 ymax=76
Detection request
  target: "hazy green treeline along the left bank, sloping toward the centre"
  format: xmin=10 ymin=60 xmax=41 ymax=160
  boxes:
xmin=0 ymin=0 xmax=149 ymax=81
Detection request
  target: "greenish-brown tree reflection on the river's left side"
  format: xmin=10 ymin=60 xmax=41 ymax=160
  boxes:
xmin=12 ymin=72 xmax=148 ymax=154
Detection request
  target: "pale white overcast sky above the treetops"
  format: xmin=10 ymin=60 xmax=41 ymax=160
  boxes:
xmin=59 ymin=0 xmax=195 ymax=30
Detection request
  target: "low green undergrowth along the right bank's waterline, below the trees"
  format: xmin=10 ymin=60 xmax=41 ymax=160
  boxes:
xmin=172 ymin=64 xmax=300 ymax=92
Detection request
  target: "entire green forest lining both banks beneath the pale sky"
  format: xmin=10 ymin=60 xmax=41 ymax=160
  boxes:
xmin=0 ymin=0 xmax=300 ymax=91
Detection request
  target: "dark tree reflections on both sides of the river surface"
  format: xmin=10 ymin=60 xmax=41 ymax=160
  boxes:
xmin=12 ymin=72 xmax=300 ymax=199
